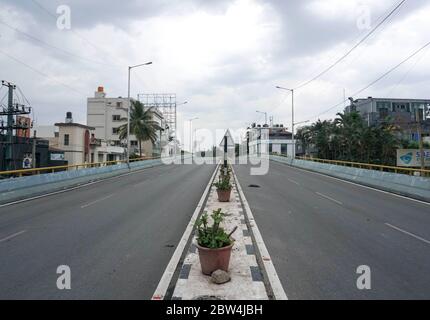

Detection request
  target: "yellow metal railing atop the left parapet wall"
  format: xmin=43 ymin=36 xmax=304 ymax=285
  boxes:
xmin=0 ymin=157 xmax=161 ymax=177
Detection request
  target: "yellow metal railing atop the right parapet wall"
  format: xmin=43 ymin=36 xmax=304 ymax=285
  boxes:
xmin=296 ymin=157 xmax=430 ymax=177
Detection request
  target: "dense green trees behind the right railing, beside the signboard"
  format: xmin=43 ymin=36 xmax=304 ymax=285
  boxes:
xmin=297 ymin=112 xmax=400 ymax=165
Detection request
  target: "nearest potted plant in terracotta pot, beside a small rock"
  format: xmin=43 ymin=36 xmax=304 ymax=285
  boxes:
xmin=196 ymin=209 xmax=237 ymax=275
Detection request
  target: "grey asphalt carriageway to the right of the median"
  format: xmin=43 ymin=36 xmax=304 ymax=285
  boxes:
xmin=235 ymin=162 xmax=430 ymax=299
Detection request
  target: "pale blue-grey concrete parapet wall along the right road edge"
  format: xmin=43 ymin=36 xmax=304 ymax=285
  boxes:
xmin=270 ymin=156 xmax=430 ymax=202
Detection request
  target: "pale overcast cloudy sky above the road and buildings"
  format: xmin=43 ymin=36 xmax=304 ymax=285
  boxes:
xmin=0 ymin=0 xmax=430 ymax=150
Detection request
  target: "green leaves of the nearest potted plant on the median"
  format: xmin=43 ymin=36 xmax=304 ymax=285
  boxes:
xmin=196 ymin=209 xmax=232 ymax=249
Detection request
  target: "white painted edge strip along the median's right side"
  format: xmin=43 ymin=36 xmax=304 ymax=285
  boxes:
xmin=232 ymin=168 xmax=288 ymax=300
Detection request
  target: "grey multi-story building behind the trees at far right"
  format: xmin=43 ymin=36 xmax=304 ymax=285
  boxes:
xmin=345 ymin=97 xmax=430 ymax=140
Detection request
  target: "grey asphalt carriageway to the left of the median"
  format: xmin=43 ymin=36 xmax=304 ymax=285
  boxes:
xmin=0 ymin=165 xmax=215 ymax=299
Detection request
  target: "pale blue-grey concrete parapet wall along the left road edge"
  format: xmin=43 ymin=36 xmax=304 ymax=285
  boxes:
xmin=0 ymin=159 xmax=168 ymax=204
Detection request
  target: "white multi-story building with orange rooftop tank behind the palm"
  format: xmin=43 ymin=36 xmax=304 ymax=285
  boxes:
xmin=87 ymin=87 xmax=167 ymax=161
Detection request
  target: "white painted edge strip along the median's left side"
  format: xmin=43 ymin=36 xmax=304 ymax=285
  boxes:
xmin=151 ymin=166 xmax=218 ymax=300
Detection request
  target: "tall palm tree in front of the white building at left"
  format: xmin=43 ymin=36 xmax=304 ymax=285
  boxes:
xmin=118 ymin=100 xmax=163 ymax=156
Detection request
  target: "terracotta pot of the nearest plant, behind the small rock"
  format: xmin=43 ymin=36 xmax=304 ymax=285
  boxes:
xmin=196 ymin=243 xmax=234 ymax=276
